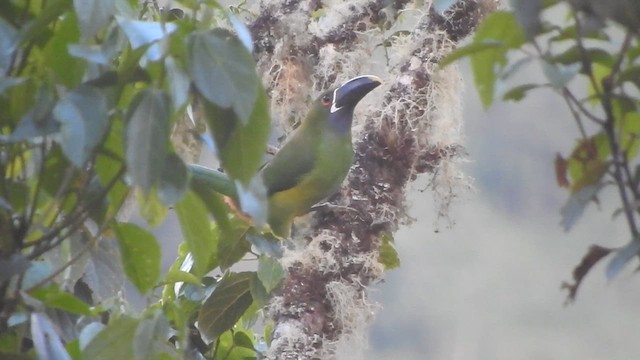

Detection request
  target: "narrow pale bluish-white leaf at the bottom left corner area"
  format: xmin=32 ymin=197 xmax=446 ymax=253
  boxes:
xmin=31 ymin=312 xmax=71 ymax=360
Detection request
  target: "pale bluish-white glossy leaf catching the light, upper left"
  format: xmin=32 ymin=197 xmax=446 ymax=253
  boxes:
xmin=116 ymin=16 xmax=178 ymax=61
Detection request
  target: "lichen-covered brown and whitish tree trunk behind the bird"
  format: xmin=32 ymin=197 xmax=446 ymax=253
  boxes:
xmin=250 ymin=0 xmax=497 ymax=359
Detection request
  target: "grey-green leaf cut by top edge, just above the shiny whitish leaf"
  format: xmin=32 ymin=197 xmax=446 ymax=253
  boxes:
xmin=73 ymin=0 xmax=116 ymax=39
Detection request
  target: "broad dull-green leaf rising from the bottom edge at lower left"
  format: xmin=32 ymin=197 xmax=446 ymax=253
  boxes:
xmin=82 ymin=316 xmax=138 ymax=360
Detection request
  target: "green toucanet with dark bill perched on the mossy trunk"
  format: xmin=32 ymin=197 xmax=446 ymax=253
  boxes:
xmin=191 ymin=75 xmax=382 ymax=238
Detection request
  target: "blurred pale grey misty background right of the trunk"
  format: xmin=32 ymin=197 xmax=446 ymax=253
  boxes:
xmin=367 ymin=62 xmax=640 ymax=360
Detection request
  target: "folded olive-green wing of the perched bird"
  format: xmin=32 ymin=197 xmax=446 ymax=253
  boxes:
xmin=262 ymin=134 xmax=317 ymax=195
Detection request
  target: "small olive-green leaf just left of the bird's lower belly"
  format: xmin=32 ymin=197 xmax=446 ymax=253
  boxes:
xmin=218 ymin=218 xmax=251 ymax=271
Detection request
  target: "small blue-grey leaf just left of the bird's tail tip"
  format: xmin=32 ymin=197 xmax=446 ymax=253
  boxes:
xmin=158 ymin=153 xmax=189 ymax=205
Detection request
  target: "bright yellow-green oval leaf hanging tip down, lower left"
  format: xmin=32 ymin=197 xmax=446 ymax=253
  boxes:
xmin=114 ymin=223 xmax=161 ymax=294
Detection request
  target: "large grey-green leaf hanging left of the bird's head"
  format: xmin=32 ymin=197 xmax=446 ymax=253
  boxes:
xmin=187 ymin=29 xmax=260 ymax=124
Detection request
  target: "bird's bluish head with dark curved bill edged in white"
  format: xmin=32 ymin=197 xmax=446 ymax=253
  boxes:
xmin=318 ymin=75 xmax=382 ymax=132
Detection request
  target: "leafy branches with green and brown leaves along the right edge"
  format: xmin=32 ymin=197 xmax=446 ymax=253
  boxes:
xmin=443 ymin=0 xmax=640 ymax=300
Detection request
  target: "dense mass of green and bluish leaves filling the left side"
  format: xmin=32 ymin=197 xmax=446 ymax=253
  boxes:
xmin=0 ymin=0 xmax=284 ymax=359
